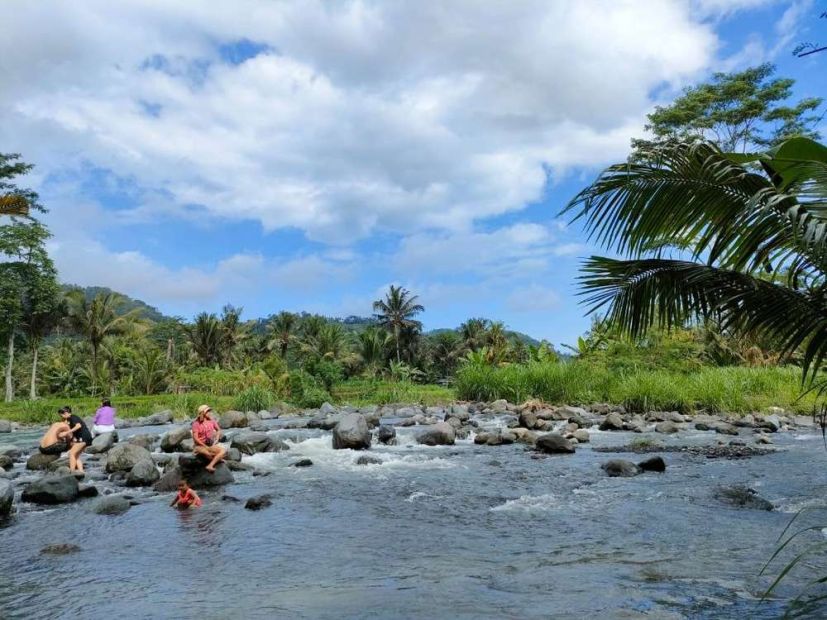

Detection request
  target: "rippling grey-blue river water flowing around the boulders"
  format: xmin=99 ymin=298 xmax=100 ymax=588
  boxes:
xmin=0 ymin=414 xmax=827 ymax=618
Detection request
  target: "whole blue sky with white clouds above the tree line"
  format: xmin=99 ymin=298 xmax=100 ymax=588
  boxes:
xmin=0 ymin=0 xmax=827 ymax=345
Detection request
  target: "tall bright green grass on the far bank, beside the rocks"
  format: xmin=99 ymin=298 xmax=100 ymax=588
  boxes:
xmin=456 ymin=362 xmax=815 ymax=413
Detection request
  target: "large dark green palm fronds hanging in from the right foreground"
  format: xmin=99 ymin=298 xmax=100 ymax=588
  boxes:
xmin=565 ymin=138 xmax=827 ymax=380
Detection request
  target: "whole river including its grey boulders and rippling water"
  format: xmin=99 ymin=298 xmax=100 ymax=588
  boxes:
xmin=0 ymin=401 xmax=827 ymax=618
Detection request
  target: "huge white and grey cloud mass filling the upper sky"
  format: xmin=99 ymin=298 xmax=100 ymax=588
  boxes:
xmin=0 ymin=0 xmax=716 ymax=244
